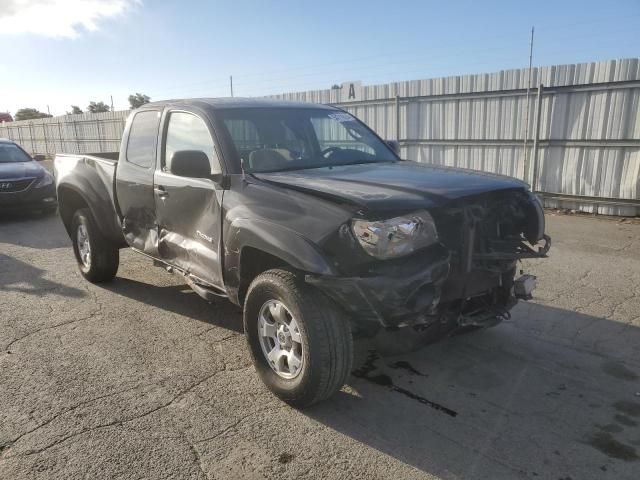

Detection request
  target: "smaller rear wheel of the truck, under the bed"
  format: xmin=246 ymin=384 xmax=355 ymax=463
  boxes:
xmin=71 ymin=208 xmax=120 ymax=283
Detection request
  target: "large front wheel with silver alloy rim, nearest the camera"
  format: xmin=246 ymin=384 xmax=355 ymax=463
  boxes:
xmin=244 ymin=269 xmax=353 ymax=408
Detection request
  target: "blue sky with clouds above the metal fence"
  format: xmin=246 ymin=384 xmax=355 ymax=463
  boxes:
xmin=0 ymin=0 xmax=640 ymax=114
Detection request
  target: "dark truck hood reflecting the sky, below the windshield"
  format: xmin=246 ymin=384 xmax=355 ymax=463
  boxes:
xmin=254 ymin=161 xmax=527 ymax=210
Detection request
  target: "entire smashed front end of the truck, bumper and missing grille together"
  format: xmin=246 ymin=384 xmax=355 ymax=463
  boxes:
xmin=306 ymin=190 xmax=551 ymax=332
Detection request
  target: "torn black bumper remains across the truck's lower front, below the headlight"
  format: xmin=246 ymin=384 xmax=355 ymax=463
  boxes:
xmin=305 ymin=231 xmax=551 ymax=327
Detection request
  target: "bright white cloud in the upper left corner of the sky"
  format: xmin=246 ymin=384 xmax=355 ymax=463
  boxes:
xmin=0 ymin=0 xmax=140 ymax=38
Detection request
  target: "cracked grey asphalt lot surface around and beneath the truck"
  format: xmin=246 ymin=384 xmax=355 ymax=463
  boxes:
xmin=0 ymin=215 xmax=640 ymax=480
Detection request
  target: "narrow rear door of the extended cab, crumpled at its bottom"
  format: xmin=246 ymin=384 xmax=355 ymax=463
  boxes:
xmin=116 ymin=110 xmax=161 ymax=256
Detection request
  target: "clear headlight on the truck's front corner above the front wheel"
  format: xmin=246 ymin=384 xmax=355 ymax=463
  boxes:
xmin=351 ymin=210 xmax=438 ymax=260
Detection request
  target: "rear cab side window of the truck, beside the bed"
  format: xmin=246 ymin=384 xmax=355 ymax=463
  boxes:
xmin=126 ymin=110 xmax=160 ymax=168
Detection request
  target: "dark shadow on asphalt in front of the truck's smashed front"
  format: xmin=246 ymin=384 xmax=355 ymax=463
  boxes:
xmin=305 ymin=304 xmax=640 ymax=479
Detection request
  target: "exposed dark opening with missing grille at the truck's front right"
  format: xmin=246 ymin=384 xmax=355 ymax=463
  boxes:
xmin=434 ymin=191 xmax=551 ymax=327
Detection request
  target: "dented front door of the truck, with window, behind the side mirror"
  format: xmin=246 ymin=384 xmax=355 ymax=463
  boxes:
xmin=155 ymin=110 xmax=223 ymax=287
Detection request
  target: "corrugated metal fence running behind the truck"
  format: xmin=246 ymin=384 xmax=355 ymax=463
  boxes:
xmin=0 ymin=59 xmax=640 ymax=215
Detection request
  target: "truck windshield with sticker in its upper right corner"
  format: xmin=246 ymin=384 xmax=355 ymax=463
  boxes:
xmin=220 ymin=108 xmax=398 ymax=172
